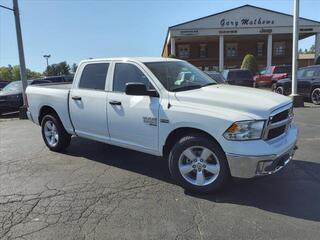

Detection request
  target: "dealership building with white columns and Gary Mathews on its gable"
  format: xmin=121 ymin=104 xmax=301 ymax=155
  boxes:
xmin=162 ymin=5 xmax=320 ymax=70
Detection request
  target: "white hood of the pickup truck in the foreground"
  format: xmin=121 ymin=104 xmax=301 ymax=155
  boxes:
xmin=175 ymin=84 xmax=292 ymax=119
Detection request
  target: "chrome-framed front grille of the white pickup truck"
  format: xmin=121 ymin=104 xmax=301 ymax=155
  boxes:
xmin=264 ymin=104 xmax=293 ymax=140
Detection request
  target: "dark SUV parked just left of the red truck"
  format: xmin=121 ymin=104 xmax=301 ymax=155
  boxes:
xmin=222 ymin=69 xmax=253 ymax=87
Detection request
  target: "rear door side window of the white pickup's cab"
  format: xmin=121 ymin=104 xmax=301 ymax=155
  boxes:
xmin=79 ymin=63 xmax=109 ymax=90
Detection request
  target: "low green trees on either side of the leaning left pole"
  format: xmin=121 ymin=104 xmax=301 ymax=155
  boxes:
xmin=0 ymin=65 xmax=42 ymax=81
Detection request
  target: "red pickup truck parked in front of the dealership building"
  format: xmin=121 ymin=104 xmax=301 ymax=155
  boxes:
xmin=254 ymin=65 xmax=292 ymax=87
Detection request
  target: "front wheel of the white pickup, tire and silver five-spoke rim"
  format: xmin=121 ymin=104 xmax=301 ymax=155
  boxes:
xmin=169 ymin=135 xmax=231 ymax=193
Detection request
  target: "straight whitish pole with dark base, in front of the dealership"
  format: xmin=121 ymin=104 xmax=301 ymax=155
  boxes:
xmin=290 ymin=0 xmax=304 ymax=107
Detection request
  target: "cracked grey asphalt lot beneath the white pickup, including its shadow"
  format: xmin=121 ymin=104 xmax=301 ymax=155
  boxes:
xmin=0 ymin=105 xmax=320 ymax=239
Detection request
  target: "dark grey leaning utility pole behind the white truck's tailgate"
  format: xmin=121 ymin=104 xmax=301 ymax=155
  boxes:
xmin=13 ymin=0 xmax=28 ymax=119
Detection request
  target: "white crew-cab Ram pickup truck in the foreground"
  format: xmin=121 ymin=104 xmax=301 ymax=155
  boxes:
xmin=27 ymin=58 xmax=298 ymax=192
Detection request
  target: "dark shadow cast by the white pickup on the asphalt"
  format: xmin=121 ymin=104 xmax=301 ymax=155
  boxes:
xmin=66 ymin=138 xmax=320 ymax=221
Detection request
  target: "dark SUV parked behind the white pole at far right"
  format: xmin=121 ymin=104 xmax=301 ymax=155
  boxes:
xmin=274 ymin=65 xmax=320 ymax=105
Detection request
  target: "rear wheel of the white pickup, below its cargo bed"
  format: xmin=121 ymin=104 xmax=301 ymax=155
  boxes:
xmin=41 ymin=113 xmax=71 ymax=152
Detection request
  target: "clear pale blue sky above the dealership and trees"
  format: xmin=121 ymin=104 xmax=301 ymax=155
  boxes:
xmin=0 ymin=0 xmax=320 ymax=72
